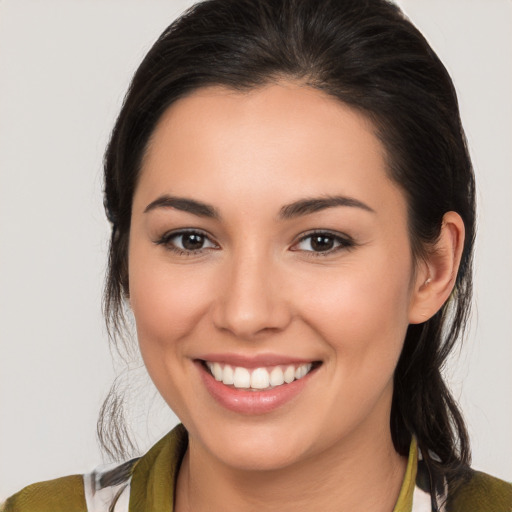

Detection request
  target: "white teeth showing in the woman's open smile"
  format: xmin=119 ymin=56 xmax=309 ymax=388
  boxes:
xmin=201 ymin=361 xmax=321 ymax=391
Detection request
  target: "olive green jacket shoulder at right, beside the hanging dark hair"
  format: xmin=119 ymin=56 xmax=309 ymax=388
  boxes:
xmin=447 ymin=470 xmax=512 ymax=512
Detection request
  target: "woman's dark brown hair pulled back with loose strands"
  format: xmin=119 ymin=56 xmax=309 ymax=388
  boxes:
xmin=99 ymin=0 xmax=475 ymax=482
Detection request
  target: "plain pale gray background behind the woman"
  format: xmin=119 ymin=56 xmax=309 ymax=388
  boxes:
xmin=0 ymin=0 xmax=512 ymax=499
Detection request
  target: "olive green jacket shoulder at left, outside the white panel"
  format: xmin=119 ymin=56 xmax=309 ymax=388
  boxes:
xmin=0 ymin=475 xmax=87 ymax=512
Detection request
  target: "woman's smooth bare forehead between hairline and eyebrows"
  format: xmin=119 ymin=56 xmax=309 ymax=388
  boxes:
xmin=138 ymin=82 xmax=404 ymax=216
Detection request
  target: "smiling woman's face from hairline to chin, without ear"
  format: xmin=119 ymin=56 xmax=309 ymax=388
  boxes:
xmin=129 ymin=82 xmax=424 ymax=469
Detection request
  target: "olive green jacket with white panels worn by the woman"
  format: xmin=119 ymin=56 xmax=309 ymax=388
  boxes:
xmin=0 ymin=425 xmax=512 ymax=512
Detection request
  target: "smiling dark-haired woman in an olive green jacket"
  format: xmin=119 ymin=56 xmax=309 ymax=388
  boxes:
xmin=5 ymin=0 xmax=512 ymax=512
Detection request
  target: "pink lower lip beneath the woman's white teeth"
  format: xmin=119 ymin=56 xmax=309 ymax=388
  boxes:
xmin=197 ymin=362 xmax=315 ymax=414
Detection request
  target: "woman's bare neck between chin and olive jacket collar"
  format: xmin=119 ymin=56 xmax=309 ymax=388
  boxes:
xmin=175 ymin=424 xmax=407 ymax=512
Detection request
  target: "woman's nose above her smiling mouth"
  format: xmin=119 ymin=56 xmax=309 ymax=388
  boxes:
xmin=213 ymin=249 xmax=292 ymax=340
